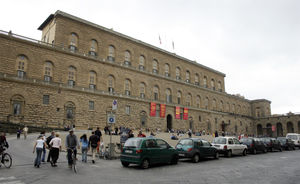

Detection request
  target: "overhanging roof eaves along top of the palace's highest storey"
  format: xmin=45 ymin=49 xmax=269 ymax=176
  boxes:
xmin=38 ymin=10 xmax=226 ymax=77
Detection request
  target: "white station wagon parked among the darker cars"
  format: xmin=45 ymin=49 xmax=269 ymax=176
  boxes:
xmin=212 ymin=137 xmax=247 ymax=157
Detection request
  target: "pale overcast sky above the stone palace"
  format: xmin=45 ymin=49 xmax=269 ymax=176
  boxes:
xmin=0 ymin=0 xmax=300 ymax=114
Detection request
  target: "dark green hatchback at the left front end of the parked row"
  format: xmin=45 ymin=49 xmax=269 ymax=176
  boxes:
xmin=121 ymin=137 xmax=178 ymax=169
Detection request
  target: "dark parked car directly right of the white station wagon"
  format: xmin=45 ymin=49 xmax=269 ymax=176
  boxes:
xmin=240 ymin=137 xmax=268 ymax=154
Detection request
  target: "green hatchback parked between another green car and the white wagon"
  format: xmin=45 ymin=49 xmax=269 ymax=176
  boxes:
xmin=175 ymin=138 xmax=219 ymax=163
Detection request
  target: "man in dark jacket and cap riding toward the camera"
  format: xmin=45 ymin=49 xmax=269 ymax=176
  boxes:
xmin=66 ymin=129 xmax=80 ymax=168
